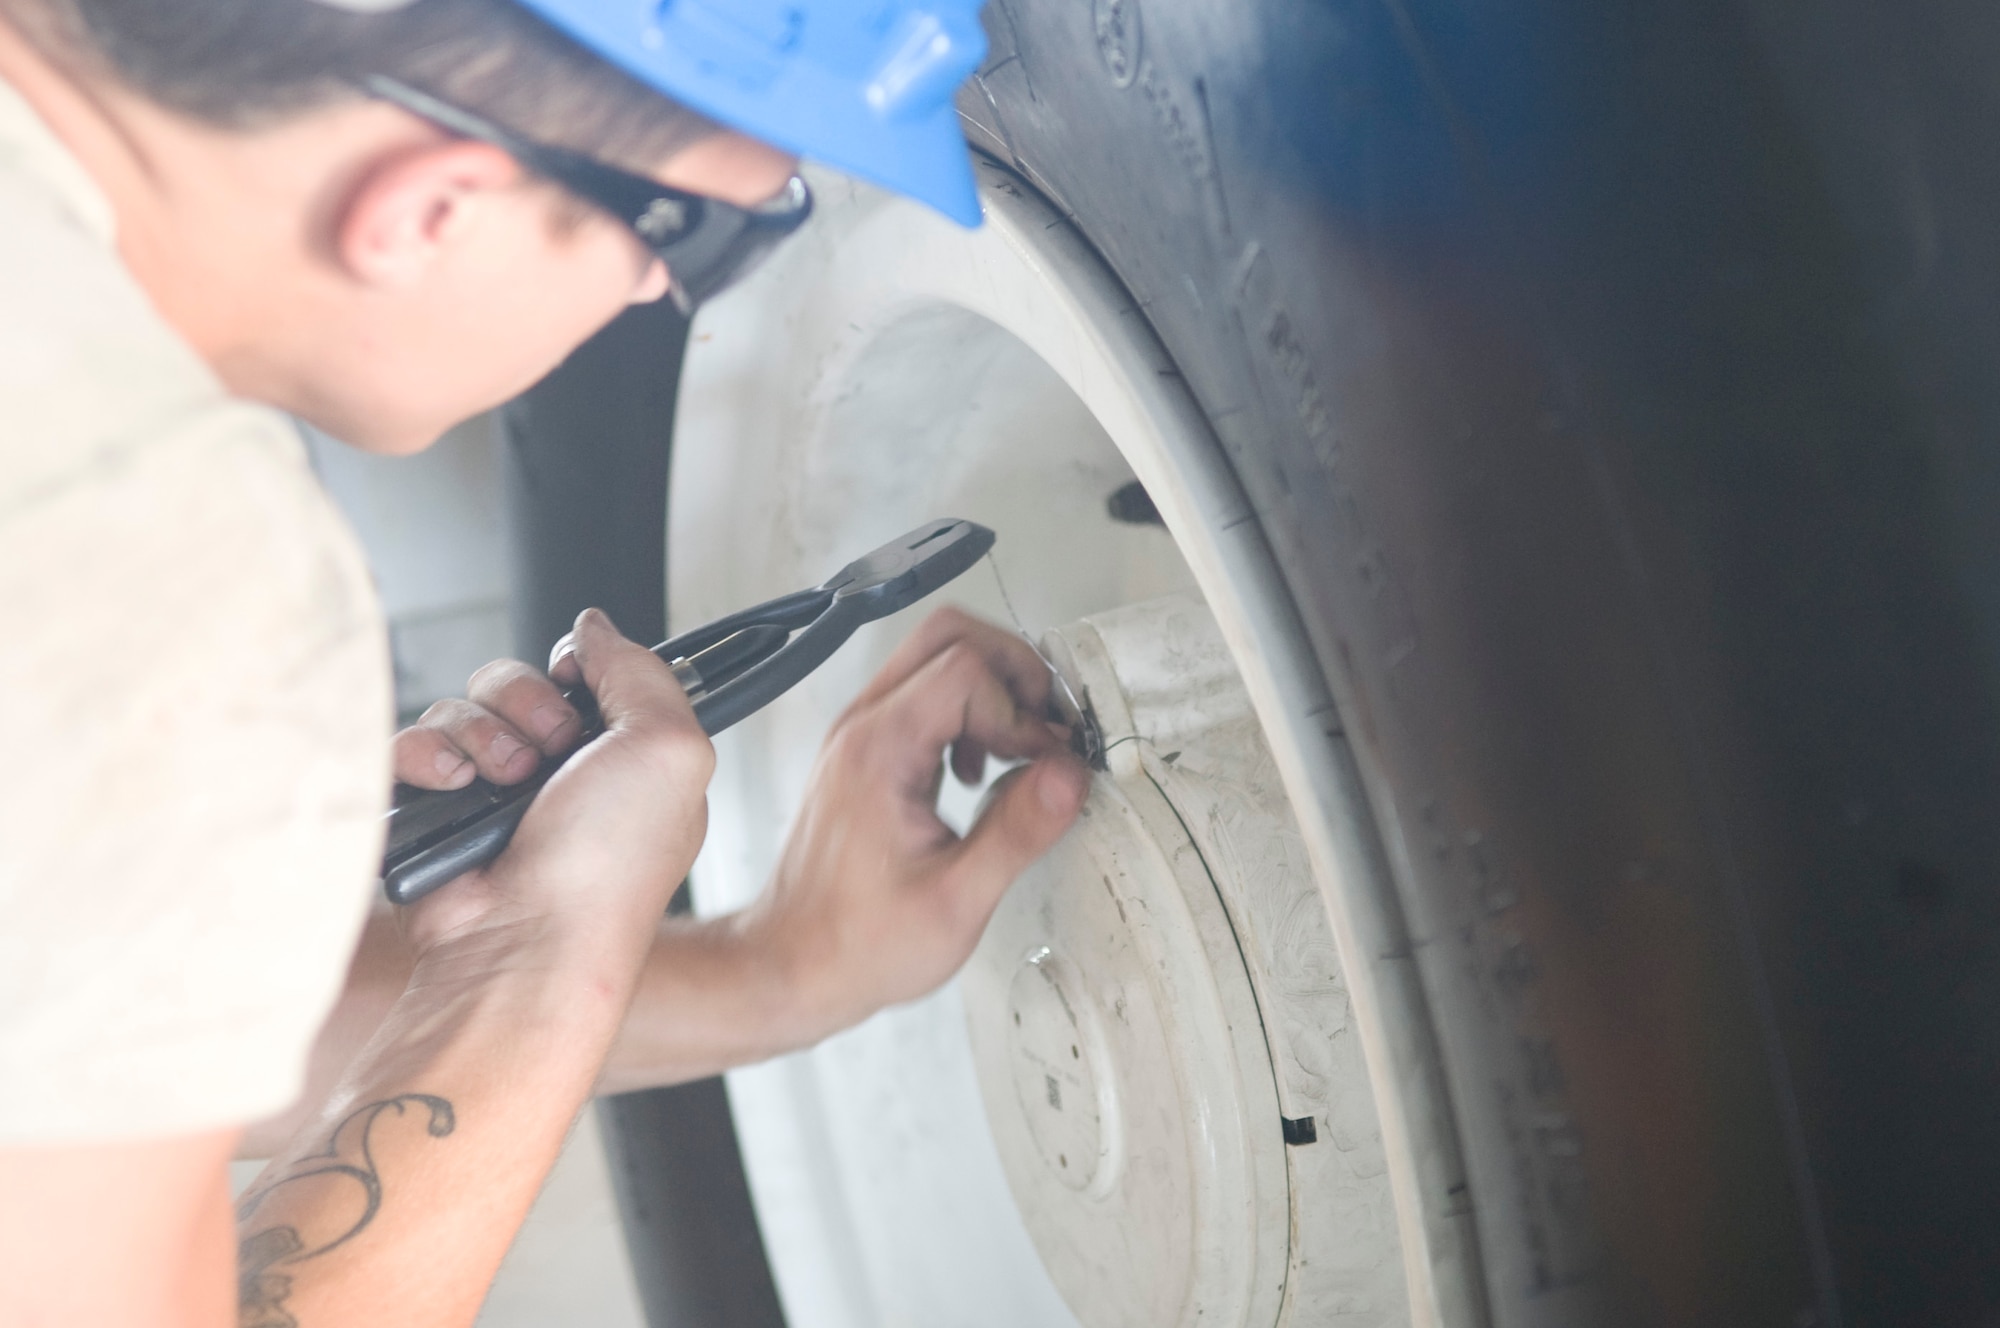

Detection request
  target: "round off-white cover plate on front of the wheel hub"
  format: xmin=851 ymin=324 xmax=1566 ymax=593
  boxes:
xmin=964 ymin=596 xmax=1288 ymax=1328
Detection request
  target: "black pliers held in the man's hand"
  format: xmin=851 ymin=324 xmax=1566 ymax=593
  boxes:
xmin=382 ymin=520 xmax=994 ymax=904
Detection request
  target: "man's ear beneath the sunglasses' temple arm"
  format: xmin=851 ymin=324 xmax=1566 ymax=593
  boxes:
xmin=334 ymin=142 xmax=522 ymax=288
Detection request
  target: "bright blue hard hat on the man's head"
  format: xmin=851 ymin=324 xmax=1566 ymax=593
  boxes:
xmin=516 ymin=0 xmax=986 ymax=226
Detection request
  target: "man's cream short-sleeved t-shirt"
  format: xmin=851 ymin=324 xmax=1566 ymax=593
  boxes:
xmin=0 ymin=82 xmax=392 ymax=1146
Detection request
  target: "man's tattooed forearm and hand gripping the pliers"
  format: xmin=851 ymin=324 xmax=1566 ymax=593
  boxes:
xmin=238 ymin=616 xmax=712 ymax=1328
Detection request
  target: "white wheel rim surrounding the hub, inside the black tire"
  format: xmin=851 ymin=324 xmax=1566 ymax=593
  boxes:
xmin=668 ymin=170 xmax=1478 ymax=1328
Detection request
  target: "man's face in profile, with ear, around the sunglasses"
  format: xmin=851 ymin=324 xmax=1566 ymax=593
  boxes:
xmin=296 ymin=134 xmax=796 ymax=454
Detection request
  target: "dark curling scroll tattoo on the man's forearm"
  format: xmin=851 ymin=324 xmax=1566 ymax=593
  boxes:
xmin=236 ymin=1092 xmax=458 ymax=1328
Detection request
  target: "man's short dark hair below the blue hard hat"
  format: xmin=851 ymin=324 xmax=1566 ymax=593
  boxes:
xmin=0 ymin=0 xmax=716 ymax=172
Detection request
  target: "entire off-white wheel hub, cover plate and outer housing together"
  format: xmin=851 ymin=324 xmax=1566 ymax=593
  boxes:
xmin=964 ymin=594 xmax=1408 ymax=1328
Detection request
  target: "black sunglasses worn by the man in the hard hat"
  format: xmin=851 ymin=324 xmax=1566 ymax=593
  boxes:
xmin=360 ymin=74 xmax=812 ymax=314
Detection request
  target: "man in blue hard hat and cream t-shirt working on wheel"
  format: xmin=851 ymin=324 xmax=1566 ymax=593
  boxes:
xmin=0 ymin=0 xmax=1084 ymax=1326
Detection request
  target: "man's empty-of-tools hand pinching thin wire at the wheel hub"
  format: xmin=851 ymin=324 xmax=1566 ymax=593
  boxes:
xmin=740 ymin=608 xmax=1088 ymax=1044
